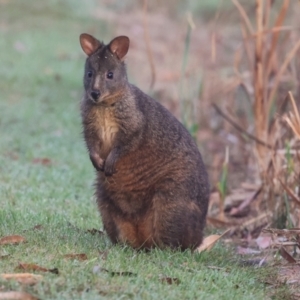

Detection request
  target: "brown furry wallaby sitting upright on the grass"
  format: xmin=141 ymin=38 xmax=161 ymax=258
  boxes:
xmin=80 ymin=34 xmax=209 ymax=249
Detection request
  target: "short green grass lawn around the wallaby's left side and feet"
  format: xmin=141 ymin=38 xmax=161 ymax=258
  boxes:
xmin=0 ymin=0 xmax=288 ymax=300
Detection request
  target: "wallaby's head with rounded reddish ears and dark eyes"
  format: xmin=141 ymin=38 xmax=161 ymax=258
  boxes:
xmin=80 ymin=33 xmax=129 ymax=104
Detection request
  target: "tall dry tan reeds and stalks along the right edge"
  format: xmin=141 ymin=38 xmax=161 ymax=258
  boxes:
xmin=209 ymin=0 xmax=300 ymax=227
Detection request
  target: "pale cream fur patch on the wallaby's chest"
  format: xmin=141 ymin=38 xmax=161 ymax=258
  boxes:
xmin=95 ymin=107 xmax=119 ymax=159
